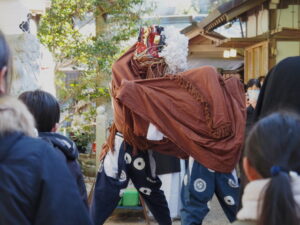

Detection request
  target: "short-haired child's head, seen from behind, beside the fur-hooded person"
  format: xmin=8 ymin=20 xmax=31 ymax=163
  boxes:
xmin=19 ymin=90 xmax=60 ymax=132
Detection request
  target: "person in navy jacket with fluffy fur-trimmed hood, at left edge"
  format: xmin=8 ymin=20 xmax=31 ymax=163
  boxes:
xmin=0 ymin=32 xmax=92 ymax=225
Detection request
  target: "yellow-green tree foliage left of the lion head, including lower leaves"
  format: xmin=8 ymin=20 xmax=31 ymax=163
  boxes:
xmin=38 ymin=0 xmax=147 ymax=149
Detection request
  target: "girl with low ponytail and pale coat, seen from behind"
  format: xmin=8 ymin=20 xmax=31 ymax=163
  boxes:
xmin=234 ymin=113 xmax=300 ymax=225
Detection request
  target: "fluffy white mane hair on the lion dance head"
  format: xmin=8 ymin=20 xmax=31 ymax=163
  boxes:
xmin=159 ymin=26 xmax=189 ymax=74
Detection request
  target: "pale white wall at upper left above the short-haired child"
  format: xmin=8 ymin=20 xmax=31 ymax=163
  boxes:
xmin=0 ymin=0 xmax=55 ymax=95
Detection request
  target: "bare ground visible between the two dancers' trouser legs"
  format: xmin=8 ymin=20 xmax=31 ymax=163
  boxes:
xmin=104 ymin=195 xmax=230 ymax=225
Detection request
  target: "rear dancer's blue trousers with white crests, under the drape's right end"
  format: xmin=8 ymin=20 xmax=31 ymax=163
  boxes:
xmin=181 ymin=161 xmax=239 ymax=225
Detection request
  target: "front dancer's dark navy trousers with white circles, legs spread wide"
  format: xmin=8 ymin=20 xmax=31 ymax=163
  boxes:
xmin=91 ymin=134 xmax=172 ymax=225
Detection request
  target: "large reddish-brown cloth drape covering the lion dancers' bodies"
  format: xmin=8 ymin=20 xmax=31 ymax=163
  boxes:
xmin=110 ymin=44 xmax=246 ymax=172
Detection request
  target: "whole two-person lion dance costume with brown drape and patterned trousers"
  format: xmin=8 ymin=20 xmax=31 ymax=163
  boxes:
xmin=91 ymin=26 xmax=246 ymax=225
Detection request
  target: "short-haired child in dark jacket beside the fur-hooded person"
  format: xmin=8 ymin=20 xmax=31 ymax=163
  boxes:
xmin=19 ymin=90 xmax=88 ymax=206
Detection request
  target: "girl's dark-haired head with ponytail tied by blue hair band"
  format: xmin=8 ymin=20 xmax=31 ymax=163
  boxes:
xmin=244 ymin=113 xmax=300 ymax=225
